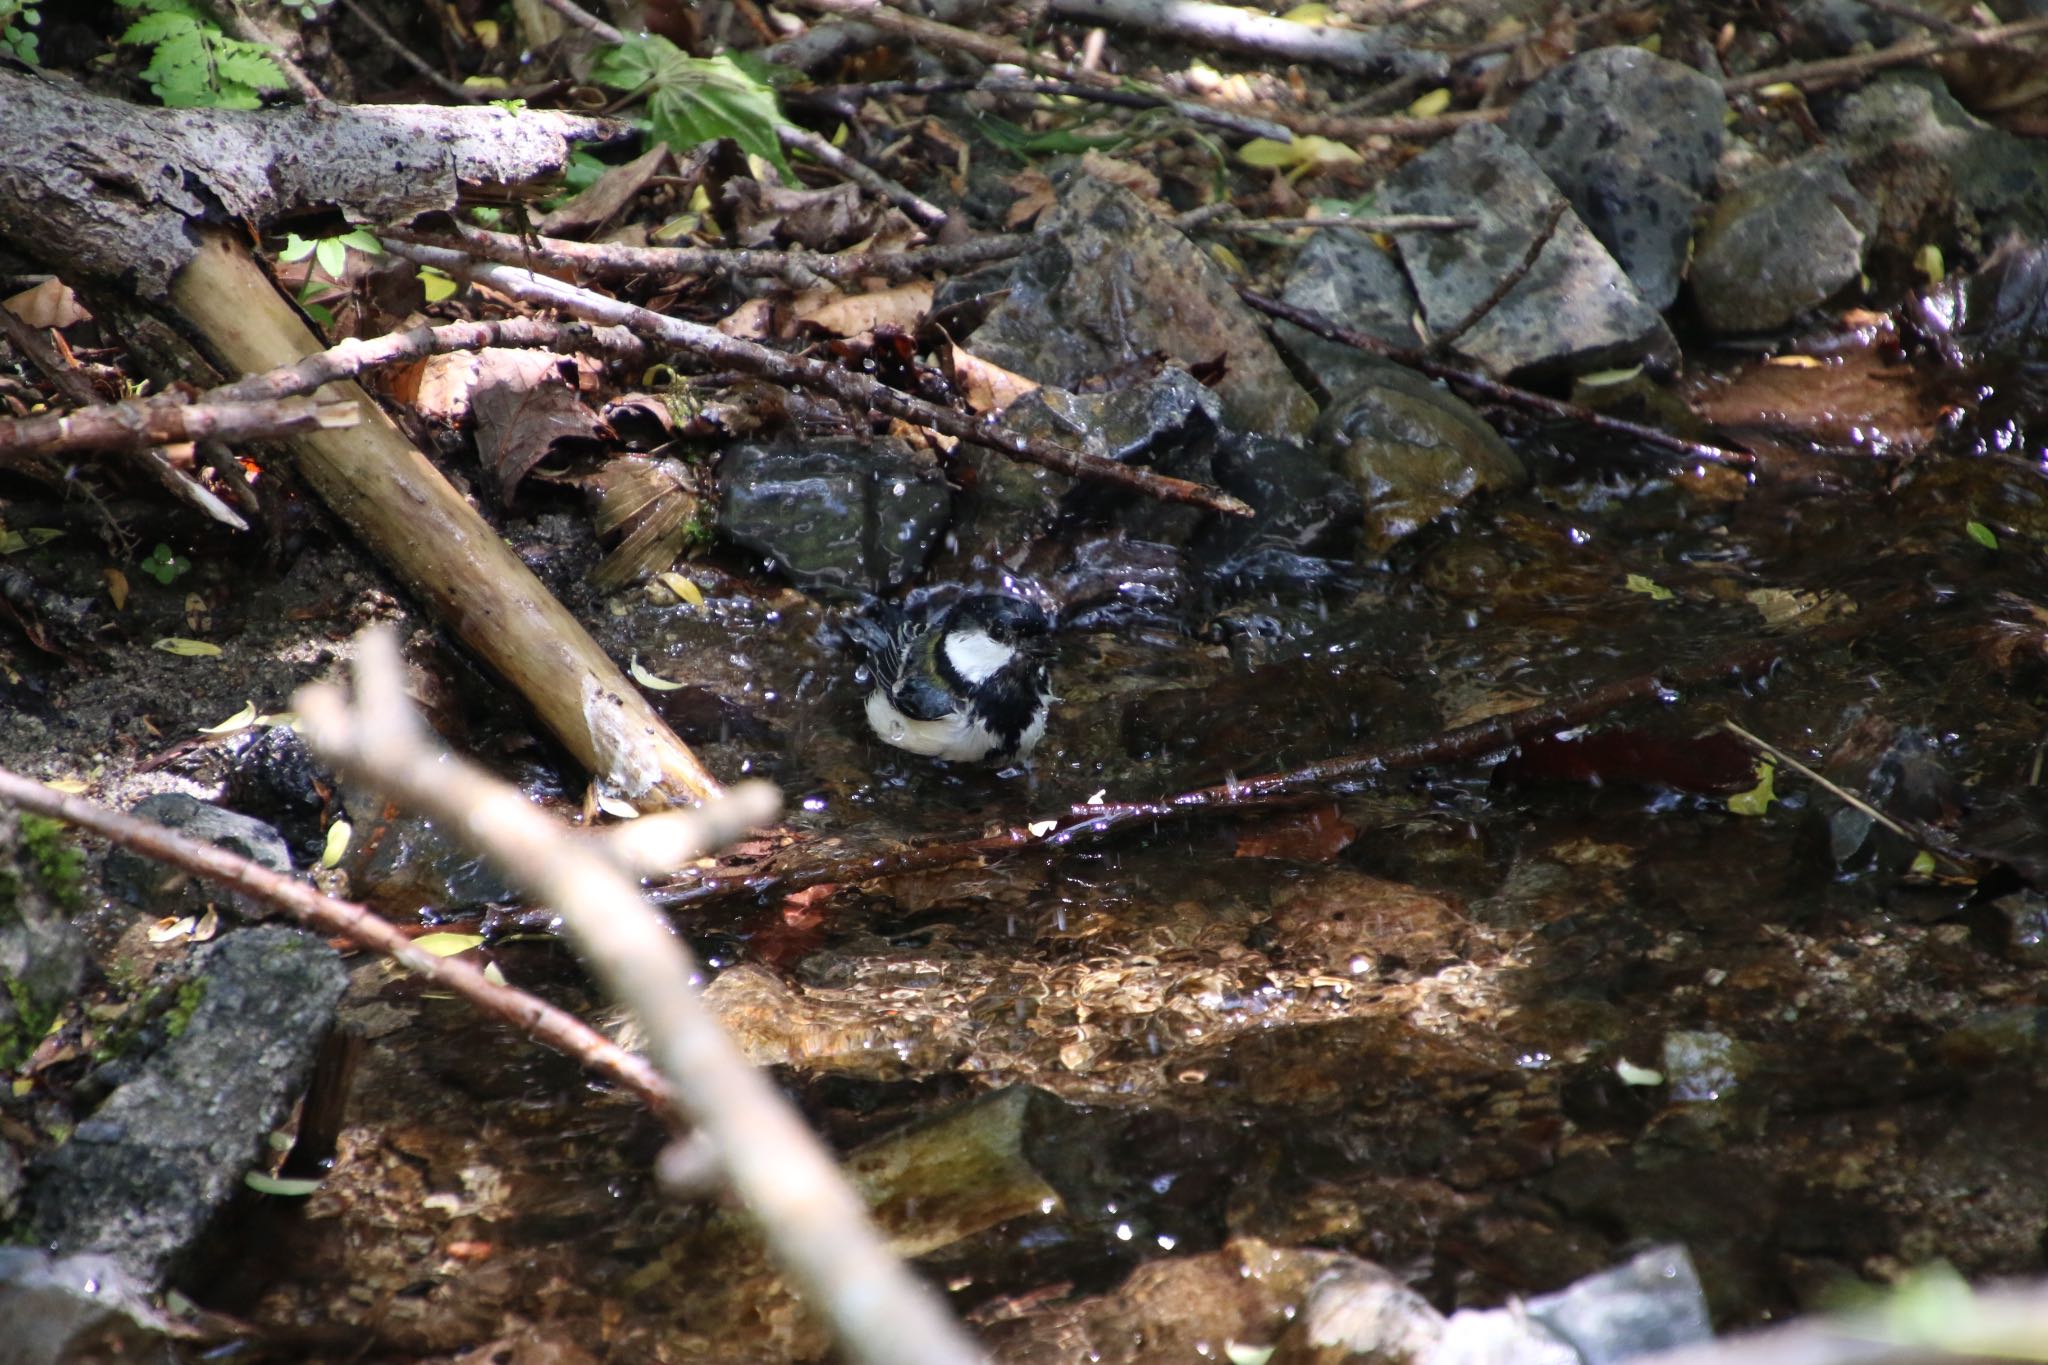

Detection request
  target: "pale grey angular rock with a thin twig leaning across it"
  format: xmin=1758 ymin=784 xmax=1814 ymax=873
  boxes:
xmin=1380 ymin=125 xmax=1677 ymax=377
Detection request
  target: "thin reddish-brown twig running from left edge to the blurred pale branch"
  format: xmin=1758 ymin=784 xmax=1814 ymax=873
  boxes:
xmin=0 ymin=767 xmax=682 ymax=1128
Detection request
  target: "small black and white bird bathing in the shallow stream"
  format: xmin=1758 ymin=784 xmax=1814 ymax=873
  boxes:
xmin=846 ymin=593 xmax=1053 ymax=763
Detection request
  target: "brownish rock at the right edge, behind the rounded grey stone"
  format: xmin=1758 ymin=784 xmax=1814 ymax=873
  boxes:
xmin=1829 ymin=72 xmax=2048 ymax=244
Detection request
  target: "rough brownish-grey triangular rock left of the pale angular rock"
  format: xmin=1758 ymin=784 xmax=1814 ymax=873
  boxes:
xmin=973 ymin=176 xmax=1315 ymax=436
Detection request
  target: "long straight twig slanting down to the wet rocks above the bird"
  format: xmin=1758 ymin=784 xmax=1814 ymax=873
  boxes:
xmin=389 ymin=241 xmax=1251 ymax=516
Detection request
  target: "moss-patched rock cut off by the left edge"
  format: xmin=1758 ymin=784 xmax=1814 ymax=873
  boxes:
xmin=0 ymin=808 xmax=86 ymax=1070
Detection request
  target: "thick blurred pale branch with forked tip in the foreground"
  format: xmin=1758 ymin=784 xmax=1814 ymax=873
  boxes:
xmin=293 ymin=630 xmax=981 ymax=1365
